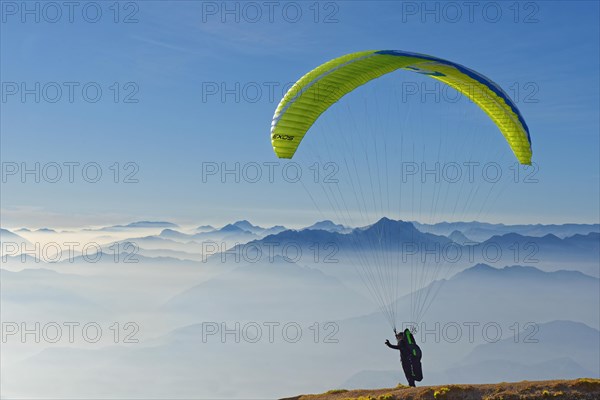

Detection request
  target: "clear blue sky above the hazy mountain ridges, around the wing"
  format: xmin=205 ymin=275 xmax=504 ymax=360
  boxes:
xmin=0 ymin=1 xmax=600 ymax=227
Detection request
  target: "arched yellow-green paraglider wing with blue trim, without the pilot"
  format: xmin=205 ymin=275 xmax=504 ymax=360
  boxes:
xmin=271 ymin=50 xmax=531 ymax=165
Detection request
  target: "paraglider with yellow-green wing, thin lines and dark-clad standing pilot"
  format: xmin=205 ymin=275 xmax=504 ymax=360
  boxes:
xmin=270 ymin=50 xmax=532 ymax=386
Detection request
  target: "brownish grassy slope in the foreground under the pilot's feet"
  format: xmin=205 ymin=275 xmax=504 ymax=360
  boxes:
xmin=283 ymin=378 xmax=600 ymax=400
